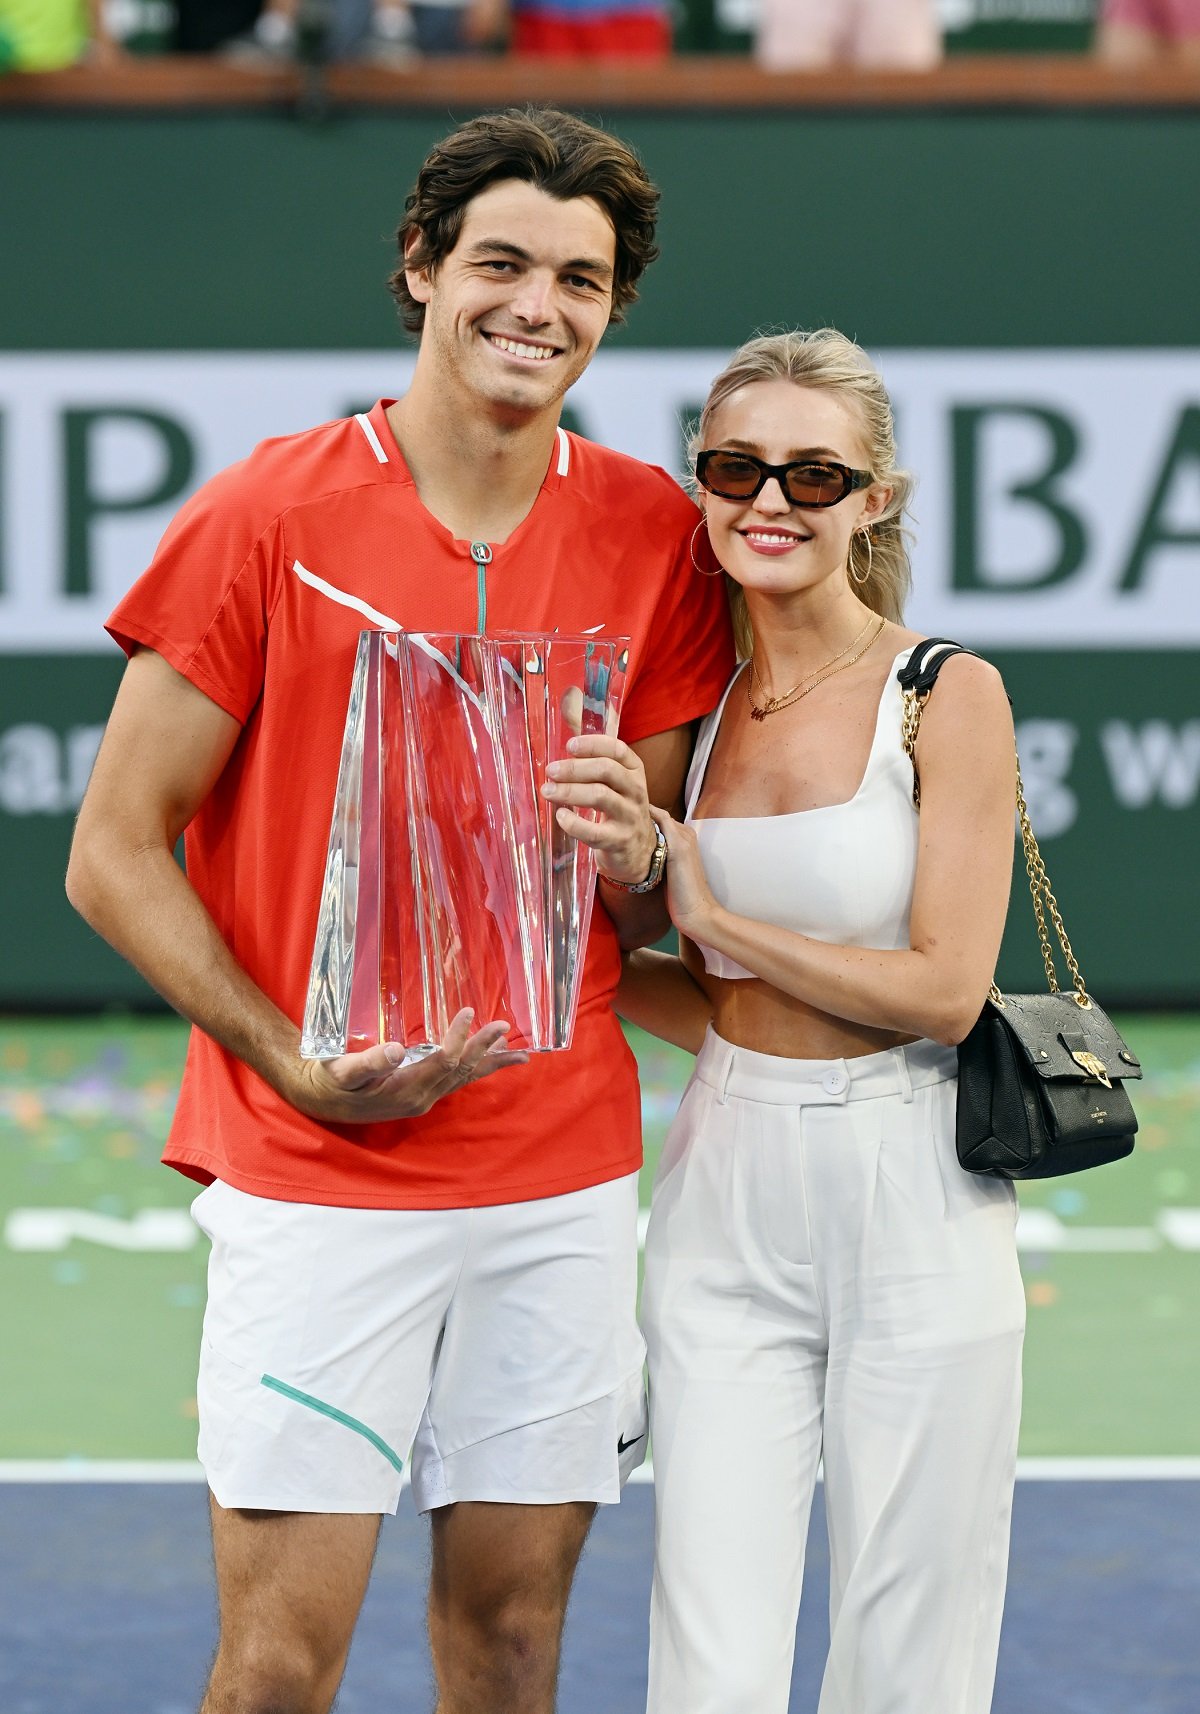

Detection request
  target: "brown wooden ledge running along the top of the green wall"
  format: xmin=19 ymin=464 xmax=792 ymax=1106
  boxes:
xmin=0 ymin=55 xmax=1200 ymax=113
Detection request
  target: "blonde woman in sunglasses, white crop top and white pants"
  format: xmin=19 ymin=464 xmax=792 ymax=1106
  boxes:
xmin=621 ymin=329 xmax=1023 ymax=1714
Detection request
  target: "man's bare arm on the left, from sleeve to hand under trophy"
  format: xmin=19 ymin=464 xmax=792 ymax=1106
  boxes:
xmin=67 ymin=648 xmax=521 ymax=1123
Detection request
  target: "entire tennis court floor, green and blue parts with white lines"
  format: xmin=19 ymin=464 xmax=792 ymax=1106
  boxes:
xmin=0 ymin=1016 xmax=1200 ymax=1714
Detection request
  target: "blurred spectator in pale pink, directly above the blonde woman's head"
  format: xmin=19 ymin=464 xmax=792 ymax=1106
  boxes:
xmin=754 ymin=0 xmax=941 ymax=72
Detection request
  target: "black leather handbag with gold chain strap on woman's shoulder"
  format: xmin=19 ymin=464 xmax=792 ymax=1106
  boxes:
xmin=897 ymin=638 xmax=1142 ymax=1178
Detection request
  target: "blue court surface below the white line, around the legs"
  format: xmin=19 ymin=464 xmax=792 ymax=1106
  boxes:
xmin=0 ymin=1476 xmax=1200 ymax=1714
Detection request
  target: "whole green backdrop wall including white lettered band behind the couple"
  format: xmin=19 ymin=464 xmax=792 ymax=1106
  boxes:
xmin=0 ymin=103 xmax=1200 ymax=1006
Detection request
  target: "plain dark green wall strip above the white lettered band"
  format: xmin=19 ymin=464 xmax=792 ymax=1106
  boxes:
xmin=0 ymin=106 xmax=1200 ymax=351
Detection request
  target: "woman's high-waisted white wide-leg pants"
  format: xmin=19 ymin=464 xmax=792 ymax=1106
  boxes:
xmin=643 ymin=1032 xmax=1025 ymax=1714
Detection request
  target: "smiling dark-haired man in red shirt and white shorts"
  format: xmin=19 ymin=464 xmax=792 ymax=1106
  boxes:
xmin=67 ymin=111 xmax=730 ymax=1714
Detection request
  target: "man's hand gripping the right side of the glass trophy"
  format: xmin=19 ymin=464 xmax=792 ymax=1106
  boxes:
xmin=542 ymin=732 xmax=657 ymax=881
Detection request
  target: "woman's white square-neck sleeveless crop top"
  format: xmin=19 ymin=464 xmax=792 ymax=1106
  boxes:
xmin=684 ymin=648 xmax=919 ymax=980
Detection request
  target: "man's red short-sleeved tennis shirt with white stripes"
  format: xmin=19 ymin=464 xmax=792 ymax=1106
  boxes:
xmin=108 ymin=399 xmax=732 ymax=1208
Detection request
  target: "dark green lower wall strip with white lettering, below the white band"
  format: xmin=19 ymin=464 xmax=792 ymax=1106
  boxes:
xmin=0 ymin=650 xmax=1200 ymax=1008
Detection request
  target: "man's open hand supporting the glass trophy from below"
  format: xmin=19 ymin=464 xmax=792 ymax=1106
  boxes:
xmin=288 ymin=1010 xmax=530 ymax=1124
